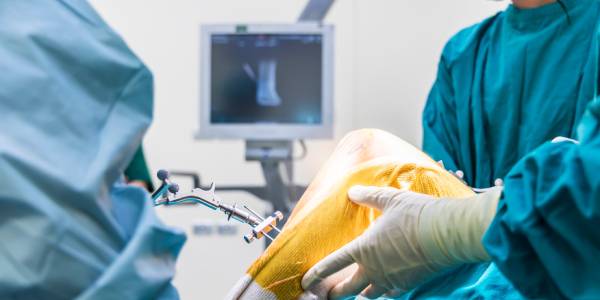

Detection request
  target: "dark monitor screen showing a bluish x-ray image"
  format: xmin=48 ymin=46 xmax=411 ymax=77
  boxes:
xmin=210 ymin=34 xmax=322 ymax=124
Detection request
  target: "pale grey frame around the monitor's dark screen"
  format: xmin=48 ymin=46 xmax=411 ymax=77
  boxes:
xmin=196 ymin=23 xmax=333 ymax=140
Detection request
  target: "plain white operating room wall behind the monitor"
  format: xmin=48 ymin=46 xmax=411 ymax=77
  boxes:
xmin=91 ymin=0 xmax=507 ymax=299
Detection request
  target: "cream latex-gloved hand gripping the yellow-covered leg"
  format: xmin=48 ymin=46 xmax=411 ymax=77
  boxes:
xmin=302 ymin=186 xmax=502 ymax=299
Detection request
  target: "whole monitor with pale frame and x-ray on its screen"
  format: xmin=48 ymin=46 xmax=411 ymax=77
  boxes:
xmin=199 ymin=23 xmax=333 ymax=140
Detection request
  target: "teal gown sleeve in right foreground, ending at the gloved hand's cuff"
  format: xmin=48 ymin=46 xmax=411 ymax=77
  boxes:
xmin=483 ymin=28 xmax=600 ymax=299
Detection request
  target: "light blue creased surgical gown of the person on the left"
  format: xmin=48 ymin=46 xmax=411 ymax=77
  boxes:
xmin=0 ymin=0 xmax=185 ymax=299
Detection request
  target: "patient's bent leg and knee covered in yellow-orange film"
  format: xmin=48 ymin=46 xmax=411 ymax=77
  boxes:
xmin=230 ymin=129 xmax=472 ymax=299
